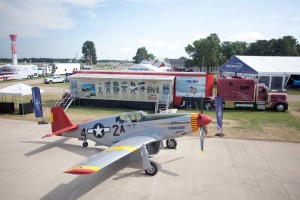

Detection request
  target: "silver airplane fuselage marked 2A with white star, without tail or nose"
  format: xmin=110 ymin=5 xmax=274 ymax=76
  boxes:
xmin=62 ymin=112 xmax=198 ymax=146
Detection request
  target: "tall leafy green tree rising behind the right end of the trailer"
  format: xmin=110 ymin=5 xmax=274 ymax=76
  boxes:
xmin=185 ymin=33 xmax=221 ymax=71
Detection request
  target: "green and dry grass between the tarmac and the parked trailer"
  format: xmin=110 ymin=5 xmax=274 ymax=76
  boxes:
xmin=0 ymin=79 xmax=300 ymax=143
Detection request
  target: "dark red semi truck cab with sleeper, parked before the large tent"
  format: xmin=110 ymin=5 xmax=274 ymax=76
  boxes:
xmin=217 ymin=77 xmax=288 ymax=112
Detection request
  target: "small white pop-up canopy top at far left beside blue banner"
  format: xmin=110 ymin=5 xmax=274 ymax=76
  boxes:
xmin=0 ymin=83 xmax=44 ymax=96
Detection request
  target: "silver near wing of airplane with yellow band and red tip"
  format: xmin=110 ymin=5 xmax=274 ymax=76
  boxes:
xmin=64 ymin=136 xmax=155 ymax=175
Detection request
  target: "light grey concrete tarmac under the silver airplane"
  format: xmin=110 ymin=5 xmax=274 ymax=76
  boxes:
xmin=0 ymin=119 xmax=300 ymax=200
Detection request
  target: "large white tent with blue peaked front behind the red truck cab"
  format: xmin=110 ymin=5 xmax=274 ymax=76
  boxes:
xmin=219 ymin=56 xmax=300 ymax=90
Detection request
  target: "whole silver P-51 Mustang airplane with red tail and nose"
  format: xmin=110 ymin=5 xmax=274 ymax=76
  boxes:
xmin=43 ymin=106 xmax=211 ymax=176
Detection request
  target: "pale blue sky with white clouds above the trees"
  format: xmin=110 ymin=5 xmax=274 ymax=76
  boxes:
xmin=0 ymin=0 xmax=300 ymax=60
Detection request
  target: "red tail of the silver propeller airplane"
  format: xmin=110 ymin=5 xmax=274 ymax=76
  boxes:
xmin=43 ymin=106 xmax=79 ymax=138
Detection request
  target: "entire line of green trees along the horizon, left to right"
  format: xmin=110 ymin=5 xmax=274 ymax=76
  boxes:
xmin=0 ymin=33 xmax=300 ymax=68
